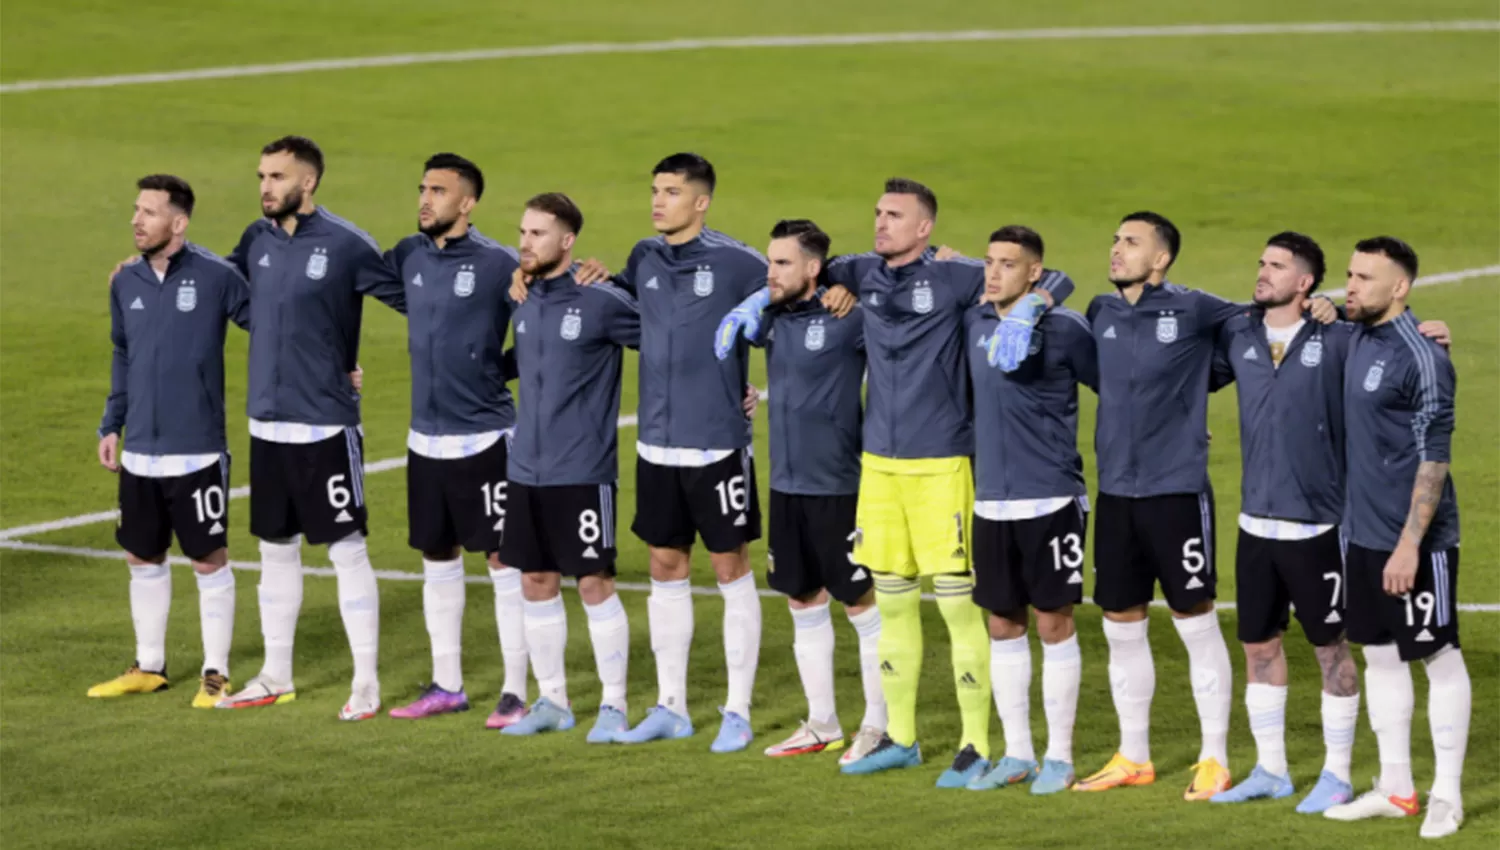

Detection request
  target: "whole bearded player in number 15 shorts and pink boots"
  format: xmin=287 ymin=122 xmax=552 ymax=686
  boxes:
xmin=387 ymin=153 xmax=527 ymax=729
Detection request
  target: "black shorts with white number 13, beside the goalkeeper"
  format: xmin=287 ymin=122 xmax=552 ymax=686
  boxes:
xmin=974 ymin=496 xmax=1089 ymax=615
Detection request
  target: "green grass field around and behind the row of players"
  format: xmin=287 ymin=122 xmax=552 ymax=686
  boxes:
xmin=0 ymin=0 xmax=1500 ymax=850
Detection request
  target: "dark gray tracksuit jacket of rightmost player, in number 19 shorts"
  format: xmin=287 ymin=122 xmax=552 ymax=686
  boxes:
xmin=1344 ymin=310 xmax=1458 ymax=552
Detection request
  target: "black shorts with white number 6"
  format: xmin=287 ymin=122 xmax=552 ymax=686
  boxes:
xmin=251 ymin=427 xmax=369 ymax=544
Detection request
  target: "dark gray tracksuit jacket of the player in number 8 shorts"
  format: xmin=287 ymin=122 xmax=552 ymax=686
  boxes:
xmin=510 ymin=273 xmax=639 ymax=487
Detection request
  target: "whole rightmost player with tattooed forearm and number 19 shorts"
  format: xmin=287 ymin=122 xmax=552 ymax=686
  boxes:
xmin=1325 ymin=237 xmax=1472 ymax=838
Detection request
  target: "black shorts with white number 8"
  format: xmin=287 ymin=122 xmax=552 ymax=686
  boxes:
xmin=500 ymin=481 xmax=617 ymax=579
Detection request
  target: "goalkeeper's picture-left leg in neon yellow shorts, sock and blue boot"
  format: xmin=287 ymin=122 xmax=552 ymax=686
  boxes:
xmin=839 ymin=456 xmax=923 ymax=775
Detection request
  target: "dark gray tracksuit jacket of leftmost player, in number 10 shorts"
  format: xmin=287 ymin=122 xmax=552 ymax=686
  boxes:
xmin=99 ymin=243 xmax=251 ymax=454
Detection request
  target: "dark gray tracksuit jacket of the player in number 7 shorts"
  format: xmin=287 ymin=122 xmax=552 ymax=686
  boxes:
xmin=1212 ymin=307 xmax=1355 ymax=525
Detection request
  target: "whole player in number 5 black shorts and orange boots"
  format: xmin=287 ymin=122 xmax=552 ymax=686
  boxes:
xmin=1074 ymin=211 xmax=1335 ymax=801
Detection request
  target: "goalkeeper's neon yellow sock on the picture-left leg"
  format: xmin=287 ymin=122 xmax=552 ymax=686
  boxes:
xmin=875 ymin=574 xmax=923 ymax=747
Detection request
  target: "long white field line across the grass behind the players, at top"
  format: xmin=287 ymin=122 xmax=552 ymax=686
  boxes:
xmin=0 ymin=21 xmax=1500 ymax=94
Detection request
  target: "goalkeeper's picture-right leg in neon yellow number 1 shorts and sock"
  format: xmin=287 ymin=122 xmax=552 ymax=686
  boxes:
xmin=903 ymin=457 xmax=990 ymax=789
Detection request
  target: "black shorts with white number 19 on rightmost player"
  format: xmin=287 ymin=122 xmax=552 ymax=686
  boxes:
xmin=1349 ymin=544 xmax=1458 ymax=661
